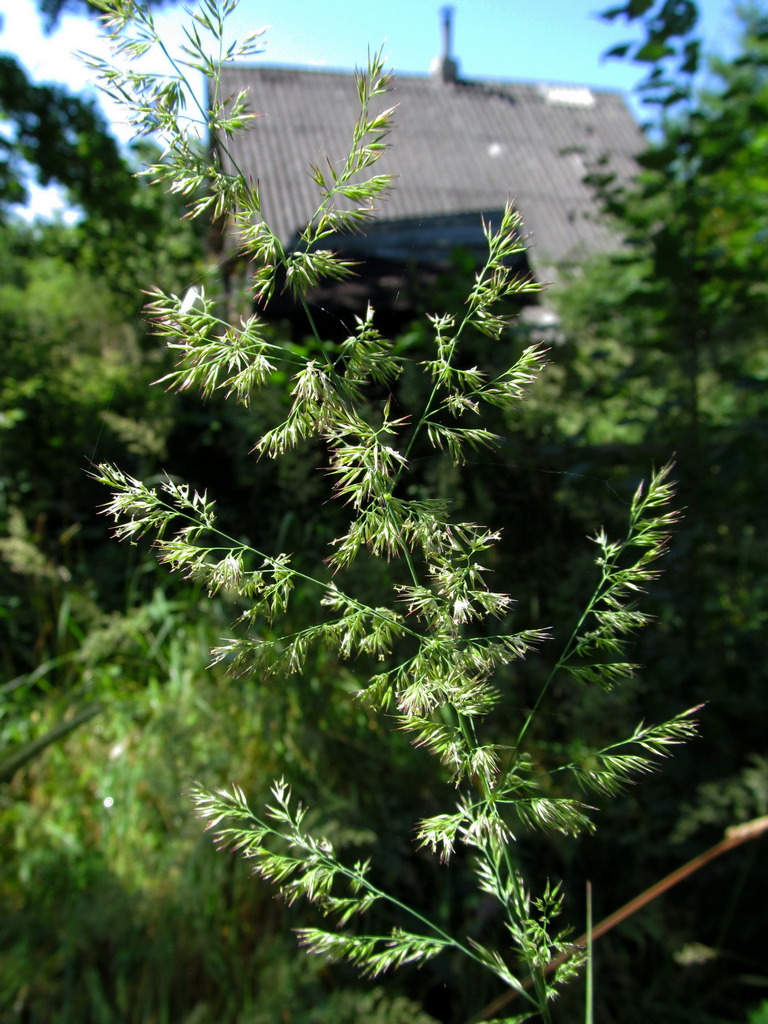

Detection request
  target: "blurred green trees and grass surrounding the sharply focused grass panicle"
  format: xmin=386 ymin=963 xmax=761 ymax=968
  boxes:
xmin=0 ymin=2 xmax=768 ymax=1024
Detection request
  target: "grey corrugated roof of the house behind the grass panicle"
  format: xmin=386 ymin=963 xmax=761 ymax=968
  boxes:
xmin=211 ymin=65 xmax=643 ymax=267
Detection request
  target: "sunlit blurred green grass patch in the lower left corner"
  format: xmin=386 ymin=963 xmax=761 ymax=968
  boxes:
xmin=0 ymin=592 xmax=301 ymax=1024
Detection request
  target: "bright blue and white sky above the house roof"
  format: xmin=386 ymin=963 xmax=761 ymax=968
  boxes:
xmin=0 ymin=0 xmax=736 ymax=216
